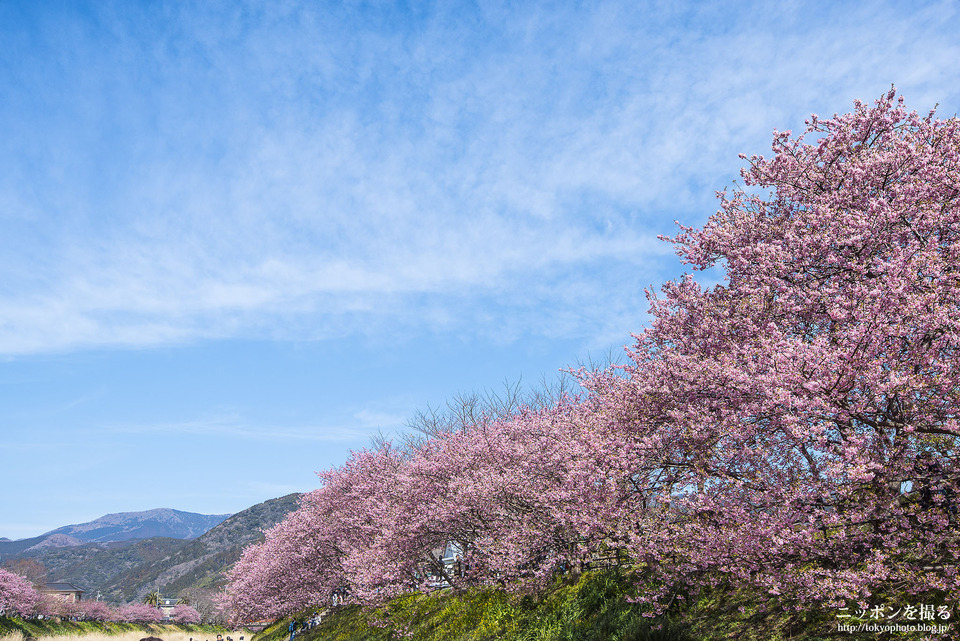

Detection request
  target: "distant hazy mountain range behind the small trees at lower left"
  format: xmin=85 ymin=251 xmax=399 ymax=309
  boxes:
xmin=0 ymin=494 xmax=300 ymax=605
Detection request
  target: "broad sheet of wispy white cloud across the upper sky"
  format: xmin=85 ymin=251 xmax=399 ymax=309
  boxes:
xmin=0 ymin=3 xmax=960 ymax=354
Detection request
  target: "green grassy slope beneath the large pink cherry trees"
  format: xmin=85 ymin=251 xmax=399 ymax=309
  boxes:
xmin=252 ymin=571 xmax=951 ymax=641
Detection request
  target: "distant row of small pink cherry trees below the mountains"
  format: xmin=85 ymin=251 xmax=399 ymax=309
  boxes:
xmin=0 ymin=568 xmax=200 ymax=623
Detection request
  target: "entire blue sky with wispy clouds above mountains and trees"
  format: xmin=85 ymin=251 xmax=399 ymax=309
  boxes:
xmin=0 ymin=0 xmax=960 ymax=538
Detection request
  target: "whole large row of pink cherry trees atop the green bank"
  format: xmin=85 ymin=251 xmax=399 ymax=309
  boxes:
xmin=226 ymin=90 xmax=960 ymax=618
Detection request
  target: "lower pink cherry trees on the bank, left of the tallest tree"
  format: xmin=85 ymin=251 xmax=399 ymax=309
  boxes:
xmin=228 ymin=399 xmax=625 ymax=619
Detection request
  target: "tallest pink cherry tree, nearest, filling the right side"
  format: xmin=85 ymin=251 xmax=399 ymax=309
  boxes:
xmin=612 ymin=86 xmax=960 ymax=604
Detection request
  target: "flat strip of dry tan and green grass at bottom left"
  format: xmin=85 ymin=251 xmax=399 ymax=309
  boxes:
xmin=0 ymin=617 xmax=236 ymax=641
